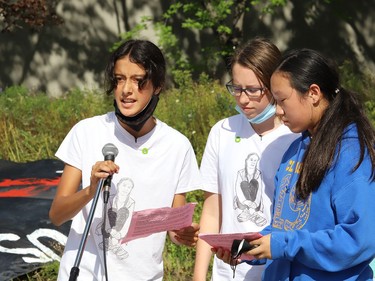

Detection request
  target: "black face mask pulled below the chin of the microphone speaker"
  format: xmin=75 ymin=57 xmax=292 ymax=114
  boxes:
xmin=113 ymin=95 xmax=159 ymax=132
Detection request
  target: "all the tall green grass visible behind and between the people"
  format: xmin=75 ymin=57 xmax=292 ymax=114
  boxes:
xmin=0 ymin=60 xmax=375 ymax=281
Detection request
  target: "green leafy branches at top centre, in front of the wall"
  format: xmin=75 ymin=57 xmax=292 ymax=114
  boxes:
xmin=114 ymin=0 xmax=286 ymax=82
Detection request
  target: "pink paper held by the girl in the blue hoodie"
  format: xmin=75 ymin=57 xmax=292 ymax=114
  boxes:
xmin=198 ymin=232 xmax=262 ymax=260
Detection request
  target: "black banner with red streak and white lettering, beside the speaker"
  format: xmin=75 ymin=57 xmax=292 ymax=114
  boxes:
xmin=0 ymin=159 xmax=70 ymax=281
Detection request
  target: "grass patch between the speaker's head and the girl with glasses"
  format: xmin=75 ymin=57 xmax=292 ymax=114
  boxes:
xmin=155 ymin=74 xmax=235 ymax=161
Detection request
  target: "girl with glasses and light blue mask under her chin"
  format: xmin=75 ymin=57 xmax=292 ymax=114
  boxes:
xmin=194 ymin=38 xmax=298 ymax=281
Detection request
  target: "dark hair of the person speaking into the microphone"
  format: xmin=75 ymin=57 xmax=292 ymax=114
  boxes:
xmin=105 ymin=40 xmax=166 ymax=94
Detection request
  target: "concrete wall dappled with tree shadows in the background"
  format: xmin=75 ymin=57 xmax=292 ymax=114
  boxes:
xmin=0 ymin=0 xmax=375 ymax=96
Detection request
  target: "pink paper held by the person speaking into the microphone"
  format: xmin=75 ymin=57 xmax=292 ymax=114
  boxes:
xmin=121 ymin=203 xmax=196 ymax=243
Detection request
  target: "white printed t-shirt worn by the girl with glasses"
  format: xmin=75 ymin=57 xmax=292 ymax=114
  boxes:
xmin=200 ymin=115 xmax=299 ymax=281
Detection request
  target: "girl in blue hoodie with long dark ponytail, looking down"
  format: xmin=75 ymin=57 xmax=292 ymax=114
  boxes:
xmin=217 ymin=49 xmax=375 ymax=281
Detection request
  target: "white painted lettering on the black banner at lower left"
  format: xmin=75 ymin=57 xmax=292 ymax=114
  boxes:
xmin=0 ymin=228 xmax=67 ymax=263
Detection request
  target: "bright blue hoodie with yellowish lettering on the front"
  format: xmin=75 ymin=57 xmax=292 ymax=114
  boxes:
xmin=262 ymin=125 xmax=375 ymax=281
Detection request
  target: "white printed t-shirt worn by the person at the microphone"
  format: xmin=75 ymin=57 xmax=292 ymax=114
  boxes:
xmin=56 ymin=112 xmax=201 ymax=281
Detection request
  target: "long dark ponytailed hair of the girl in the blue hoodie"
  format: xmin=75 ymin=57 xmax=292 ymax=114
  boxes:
xmin=276 ymin=49 xmax=375 ymax=199
